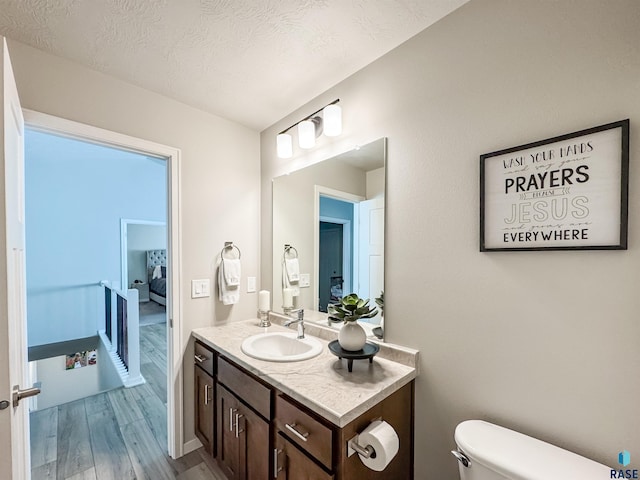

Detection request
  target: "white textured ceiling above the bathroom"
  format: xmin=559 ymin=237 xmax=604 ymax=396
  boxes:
xmin=0 ymin=0 xmax=468 ymax=131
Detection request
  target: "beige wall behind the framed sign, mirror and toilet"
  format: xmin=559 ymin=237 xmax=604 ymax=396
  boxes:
xmin=261 ymin=0 xmax=640 ymax=480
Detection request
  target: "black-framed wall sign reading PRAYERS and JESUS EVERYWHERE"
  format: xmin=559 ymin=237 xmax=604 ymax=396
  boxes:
xmin=480 ymin=119 xmax=629 ymax=252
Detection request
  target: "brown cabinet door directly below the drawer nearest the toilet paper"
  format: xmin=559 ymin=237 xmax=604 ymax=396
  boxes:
xmin=273 ymin=434 xmax=334 ymax=480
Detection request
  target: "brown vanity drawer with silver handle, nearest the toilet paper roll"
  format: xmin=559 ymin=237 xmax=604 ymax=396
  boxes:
xmin=276 ymin=395 xmax=333 ymax=469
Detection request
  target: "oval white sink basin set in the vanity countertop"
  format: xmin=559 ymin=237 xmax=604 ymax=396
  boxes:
xmin=241 ymin=332 xmax=322 ymax=362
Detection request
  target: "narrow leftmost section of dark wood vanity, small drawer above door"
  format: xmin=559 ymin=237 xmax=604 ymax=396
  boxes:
xmin=193 ymin=342 xmax=215 ymax=455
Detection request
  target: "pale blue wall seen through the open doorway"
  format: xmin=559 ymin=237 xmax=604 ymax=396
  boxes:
xmin=25 ymin=130 xmax=167 ymax=346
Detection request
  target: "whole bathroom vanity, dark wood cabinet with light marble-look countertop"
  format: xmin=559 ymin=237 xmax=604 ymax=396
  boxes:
xmin=193 ymin=320 xmax=417 ymax=480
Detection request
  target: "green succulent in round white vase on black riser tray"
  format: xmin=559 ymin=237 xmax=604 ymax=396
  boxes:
xmin=329 ymin=293 xmax=378 ymax=352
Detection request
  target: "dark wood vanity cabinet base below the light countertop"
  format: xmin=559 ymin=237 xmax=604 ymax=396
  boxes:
xmin=196 ymin=343 xmax=414 ymax=480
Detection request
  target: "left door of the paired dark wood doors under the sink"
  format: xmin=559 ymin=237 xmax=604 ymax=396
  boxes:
xmin=217 ymin=384 xmax=243 ymax=480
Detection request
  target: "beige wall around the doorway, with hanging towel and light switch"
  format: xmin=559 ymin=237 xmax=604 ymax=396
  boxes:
xmin=8 ymin=40 xmax=260 ymax=441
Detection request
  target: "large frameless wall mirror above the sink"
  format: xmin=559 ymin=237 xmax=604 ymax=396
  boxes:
xmin=272 ymin=138 xmax=386 ymax=338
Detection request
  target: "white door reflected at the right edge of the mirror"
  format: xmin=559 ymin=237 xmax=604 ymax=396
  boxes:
xmin=358 ymin=198 xmax=384 ymax=323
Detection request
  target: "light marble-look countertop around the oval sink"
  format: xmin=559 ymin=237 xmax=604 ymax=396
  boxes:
xmin=192 ymin=319 xmax=418 ymax=427
